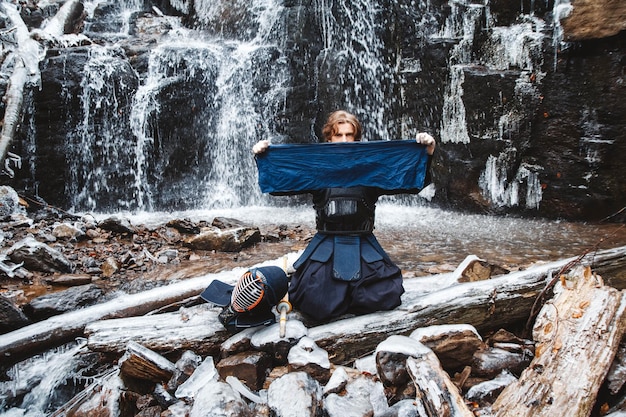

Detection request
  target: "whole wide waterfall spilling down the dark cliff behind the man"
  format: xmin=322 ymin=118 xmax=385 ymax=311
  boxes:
xmin=4 ymin=0 xmax=593 ymax=212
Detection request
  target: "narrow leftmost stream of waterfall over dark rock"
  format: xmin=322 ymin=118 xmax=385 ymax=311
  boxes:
xmin=65 ymin=46 xmax=141 ymax=210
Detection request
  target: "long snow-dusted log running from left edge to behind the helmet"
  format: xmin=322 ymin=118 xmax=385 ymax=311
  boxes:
xmin=0 ymin=253 xmax=298 ymax=366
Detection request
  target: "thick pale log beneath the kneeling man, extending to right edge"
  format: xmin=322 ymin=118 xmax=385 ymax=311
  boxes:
xmin=86 ymin=247 xmax=626 ymax=364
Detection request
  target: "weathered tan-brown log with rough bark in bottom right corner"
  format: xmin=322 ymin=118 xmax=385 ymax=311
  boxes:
xmin=492 ymin=268 xmax=626 ymax=417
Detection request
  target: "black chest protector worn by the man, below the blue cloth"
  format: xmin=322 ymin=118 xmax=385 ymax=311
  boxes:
xmin=313 ymin=187 xmax=378 ymax=234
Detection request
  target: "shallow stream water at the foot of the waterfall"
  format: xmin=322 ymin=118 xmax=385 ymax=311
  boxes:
xmin=114 ymin=203 xmax=626 ymax=276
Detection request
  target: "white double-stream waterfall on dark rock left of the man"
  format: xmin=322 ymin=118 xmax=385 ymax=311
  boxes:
xmin=67 ymin=0 xmax=289 ymax=211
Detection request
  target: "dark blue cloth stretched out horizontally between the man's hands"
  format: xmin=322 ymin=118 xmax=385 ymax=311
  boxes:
xmin=256 ymin=140 xmax=428 ymax=193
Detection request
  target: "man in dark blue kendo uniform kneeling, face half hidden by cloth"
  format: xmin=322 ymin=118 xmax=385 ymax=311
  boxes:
xmin=253 ymin=110 xmax=436 ymax=320
